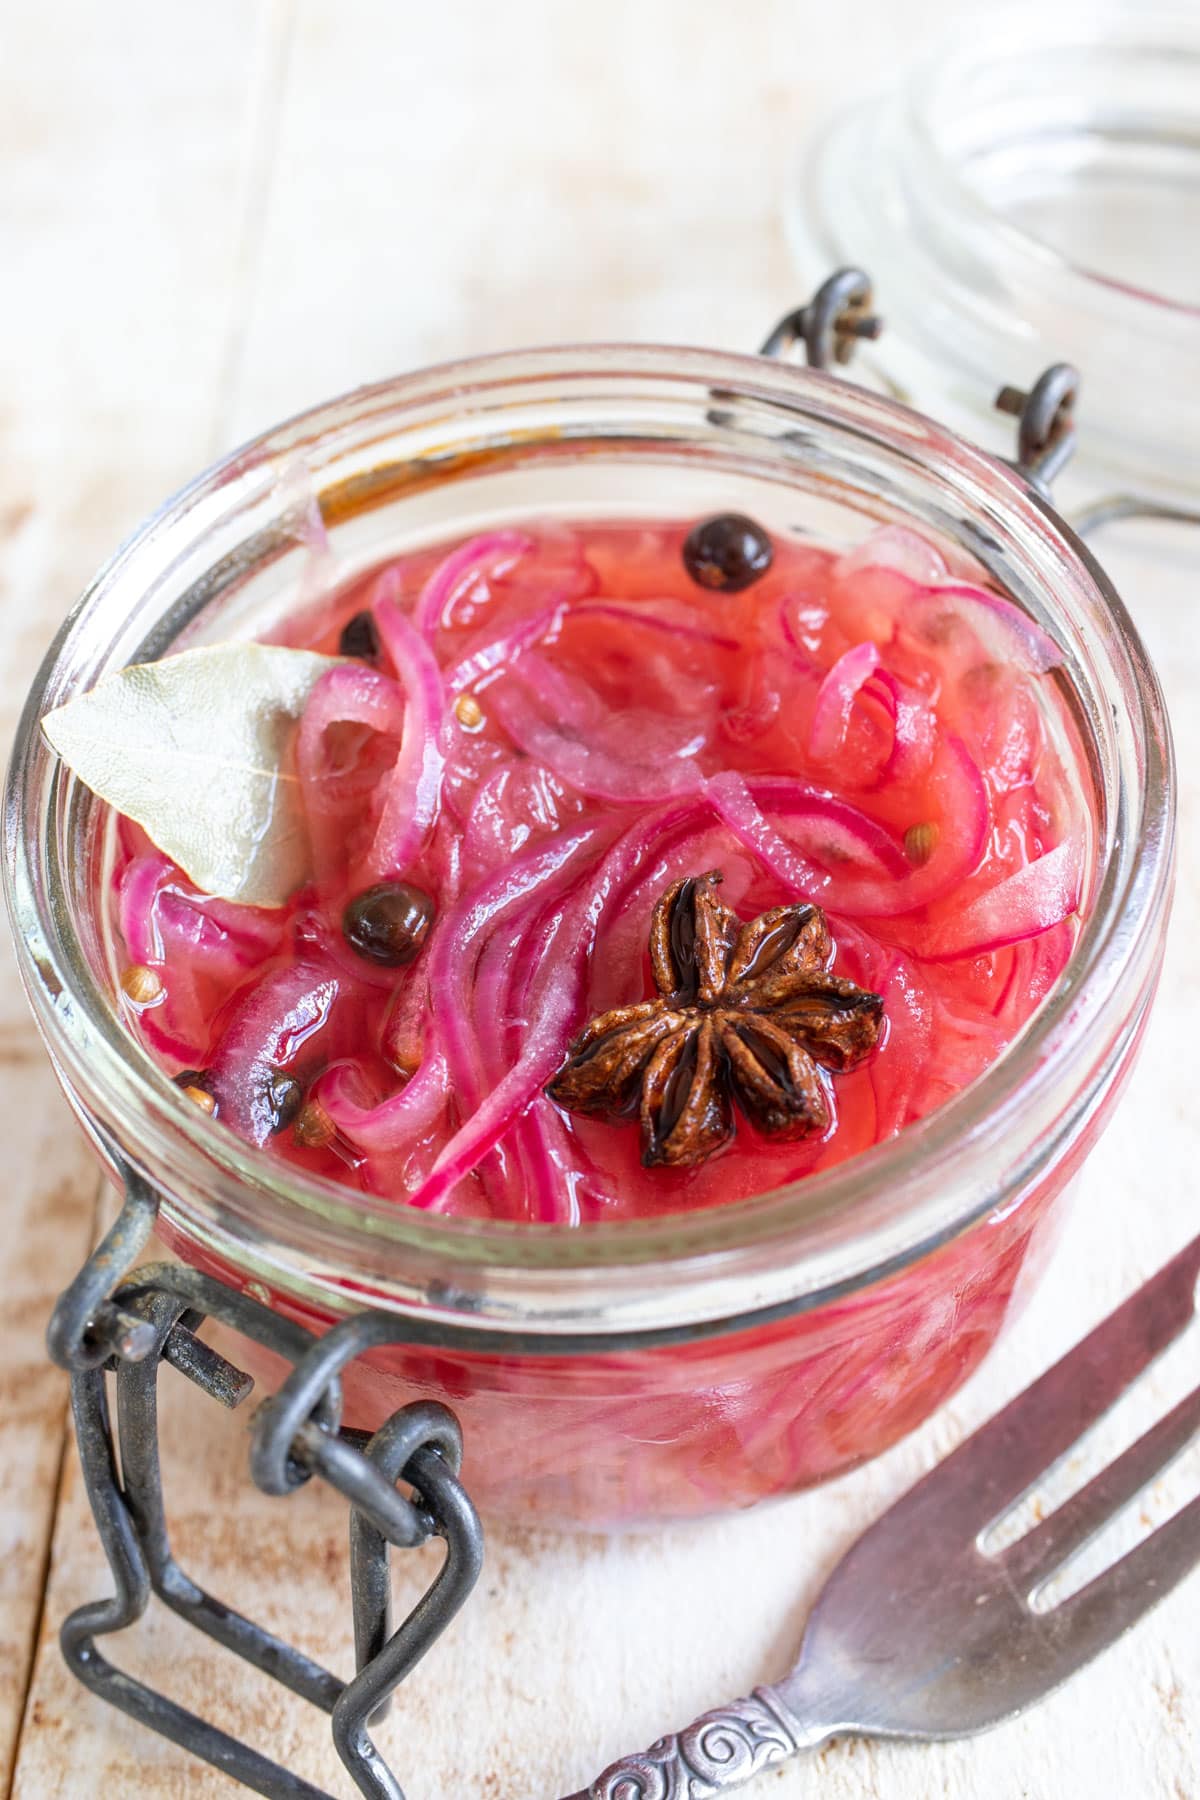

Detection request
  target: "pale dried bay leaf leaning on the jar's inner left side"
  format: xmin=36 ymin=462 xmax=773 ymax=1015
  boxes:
xmin=41 ymin=643 xmax=340 ymax=907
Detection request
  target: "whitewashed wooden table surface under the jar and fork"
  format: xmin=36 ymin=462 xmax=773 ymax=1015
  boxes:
xmin=0 ymin=0 xmax=1200 ymax=1800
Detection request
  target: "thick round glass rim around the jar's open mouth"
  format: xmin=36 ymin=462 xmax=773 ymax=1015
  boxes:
xmin=5 ymin=344 xmax=1173 ymax=1334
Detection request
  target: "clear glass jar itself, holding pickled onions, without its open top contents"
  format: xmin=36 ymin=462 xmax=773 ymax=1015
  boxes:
xmin=5 ymin=346 xmax=1173 ymax=1525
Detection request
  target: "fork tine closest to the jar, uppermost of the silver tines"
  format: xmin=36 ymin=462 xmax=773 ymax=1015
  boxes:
xmin=937 ymin=1237 xmax=1200 ymax=1532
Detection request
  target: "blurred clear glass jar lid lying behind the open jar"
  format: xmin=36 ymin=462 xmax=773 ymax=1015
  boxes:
xmin=788 ymin=0 xmax=1200 ymax=506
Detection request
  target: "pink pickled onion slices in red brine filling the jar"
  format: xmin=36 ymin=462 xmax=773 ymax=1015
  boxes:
xmin=106 ymin=507 xmax=1092 ymax=1224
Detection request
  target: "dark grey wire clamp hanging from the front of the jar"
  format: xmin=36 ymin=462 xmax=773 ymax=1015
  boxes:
xmin=47 ymin=1172 xmax=482 ymax=1800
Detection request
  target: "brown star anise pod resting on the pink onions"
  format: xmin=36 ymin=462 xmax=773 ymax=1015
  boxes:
xmin=547 ymin=869 xmax=883 ymax=1168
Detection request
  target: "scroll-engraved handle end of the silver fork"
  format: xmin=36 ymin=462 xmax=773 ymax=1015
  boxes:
xmin=570 ymin=1687 xmax=828 ymax=1800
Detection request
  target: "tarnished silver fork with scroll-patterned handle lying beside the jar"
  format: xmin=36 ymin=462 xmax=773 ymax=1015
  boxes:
xmin=570 ymin=1237 xmax=1200 ymax=1800
